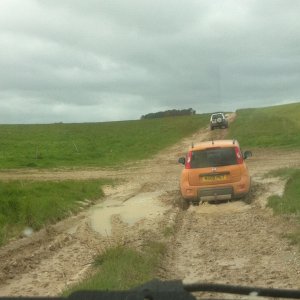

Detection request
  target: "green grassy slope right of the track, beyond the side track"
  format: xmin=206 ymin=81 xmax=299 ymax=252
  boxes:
xmin=228 ymin=103 xmax=300 ymax=148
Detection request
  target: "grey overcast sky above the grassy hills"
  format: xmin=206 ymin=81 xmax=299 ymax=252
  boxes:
xmin=0 ymin=0 xmax=300 ymax=124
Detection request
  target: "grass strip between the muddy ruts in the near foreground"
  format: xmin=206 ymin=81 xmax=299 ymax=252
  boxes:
xmin=63 ymin=241 xmax=166 ymax=296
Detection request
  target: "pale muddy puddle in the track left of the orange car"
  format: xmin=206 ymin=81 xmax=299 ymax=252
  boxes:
xmin=90 ymin=192 xmax=167 ymax=235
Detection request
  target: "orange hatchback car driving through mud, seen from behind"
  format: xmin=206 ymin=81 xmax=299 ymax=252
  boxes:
xmin=178 ymin=140 xmax=252 ymax=203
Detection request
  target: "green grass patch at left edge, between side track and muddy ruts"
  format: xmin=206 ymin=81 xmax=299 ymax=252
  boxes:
xmin=0 ymin=180 xmax=109 ymax=244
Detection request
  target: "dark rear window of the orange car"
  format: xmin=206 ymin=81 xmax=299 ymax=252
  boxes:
xmin=191 ymin=147 xmax=237 ymax=169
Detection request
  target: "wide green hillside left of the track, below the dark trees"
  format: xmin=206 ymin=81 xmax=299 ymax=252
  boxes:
xmin=0 ymin=115 xmax=209 ymax=169
